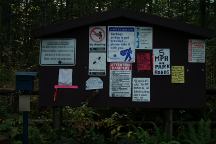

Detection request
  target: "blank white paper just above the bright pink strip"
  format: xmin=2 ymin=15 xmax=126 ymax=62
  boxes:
xmin=58 ymin=69 xmax=72 ymax=85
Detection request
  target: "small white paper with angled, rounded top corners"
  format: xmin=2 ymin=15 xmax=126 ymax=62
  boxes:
xmin=86 ymin=77 xmax=103 ymax=90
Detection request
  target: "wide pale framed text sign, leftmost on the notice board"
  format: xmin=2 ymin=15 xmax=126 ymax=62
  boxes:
xmin=40 ymin=39 xmax=76 ymax=66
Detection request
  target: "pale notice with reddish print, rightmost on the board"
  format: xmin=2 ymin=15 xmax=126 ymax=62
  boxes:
xmin=188 ymin=39 xmax=205 ymax=63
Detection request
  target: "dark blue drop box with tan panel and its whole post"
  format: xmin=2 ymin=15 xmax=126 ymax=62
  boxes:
xmin=16 ymin=72 xmax=37 ymax=144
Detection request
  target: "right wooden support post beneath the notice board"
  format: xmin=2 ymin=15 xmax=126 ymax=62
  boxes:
xmin=165 ymin=109 xmax=173 ymax=140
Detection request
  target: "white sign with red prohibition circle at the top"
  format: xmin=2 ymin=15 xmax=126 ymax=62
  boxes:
xmin=89 ymin=26 xmax=106 ymax=52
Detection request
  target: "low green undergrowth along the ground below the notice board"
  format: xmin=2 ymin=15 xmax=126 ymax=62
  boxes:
xmin=0 ymin=104 xmax=216 ymax=144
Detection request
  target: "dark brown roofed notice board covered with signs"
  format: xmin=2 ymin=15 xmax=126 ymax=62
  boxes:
xmin=35 ymin=11 xmax=211 ymax=108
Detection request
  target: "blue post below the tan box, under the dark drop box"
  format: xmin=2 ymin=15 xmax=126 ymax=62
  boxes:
xmin=23 ymin=111 xmax=29 ymax=144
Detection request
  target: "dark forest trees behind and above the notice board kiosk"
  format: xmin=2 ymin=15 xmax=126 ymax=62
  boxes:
xmin=0 ymin=0 xmax=216 ymax=88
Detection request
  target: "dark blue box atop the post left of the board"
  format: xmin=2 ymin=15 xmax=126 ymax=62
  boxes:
xmin=16 ymin=72 xmax=37 ymax=92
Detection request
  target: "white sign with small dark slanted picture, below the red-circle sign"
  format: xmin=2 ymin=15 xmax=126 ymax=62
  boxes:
xmin=88 ymin=52 xmax=106 ymax=76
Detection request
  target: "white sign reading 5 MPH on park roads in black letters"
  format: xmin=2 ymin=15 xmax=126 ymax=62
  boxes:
xmin=153 ymin=49 xmax=170 ymax=75
